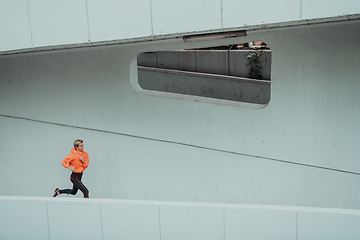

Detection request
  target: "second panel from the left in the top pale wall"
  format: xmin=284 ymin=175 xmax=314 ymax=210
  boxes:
xmin=29 ymin=0 xmax=89 ymax=47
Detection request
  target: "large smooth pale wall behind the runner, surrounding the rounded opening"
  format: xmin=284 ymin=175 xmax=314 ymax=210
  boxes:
xmin=0 ymin=22 xmax=360 ymax=210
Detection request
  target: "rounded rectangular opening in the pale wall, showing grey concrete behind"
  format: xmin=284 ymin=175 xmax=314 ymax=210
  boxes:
xmin=137 ymin=41 xmax=271 ymax=108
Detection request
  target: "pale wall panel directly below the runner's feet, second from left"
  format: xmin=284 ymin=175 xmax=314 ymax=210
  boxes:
xmin=47 ymin=199 xmax=102 ymax=240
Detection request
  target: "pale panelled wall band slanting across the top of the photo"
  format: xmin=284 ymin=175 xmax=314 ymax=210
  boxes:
xmin=0 ymin=0 xmax=360 ymax=51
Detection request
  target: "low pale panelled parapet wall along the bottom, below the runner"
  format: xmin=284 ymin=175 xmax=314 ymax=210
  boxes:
xmin=0 ymin=197 xmax=360 ymax=240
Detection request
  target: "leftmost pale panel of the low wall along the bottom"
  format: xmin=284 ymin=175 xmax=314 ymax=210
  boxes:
xmin=0 ymin=199 xmax=49 ymax=240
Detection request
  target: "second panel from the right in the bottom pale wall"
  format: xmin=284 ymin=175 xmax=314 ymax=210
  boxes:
xmin=225 ymin=208 xmax=297 ymax=240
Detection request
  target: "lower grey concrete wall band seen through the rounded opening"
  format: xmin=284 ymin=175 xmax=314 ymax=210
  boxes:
xmin=138 ymin=67 xmax=270 ymax=105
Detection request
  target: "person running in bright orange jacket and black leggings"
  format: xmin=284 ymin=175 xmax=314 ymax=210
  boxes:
xmin=53 ymin=139 xmax=89 ymax=198
